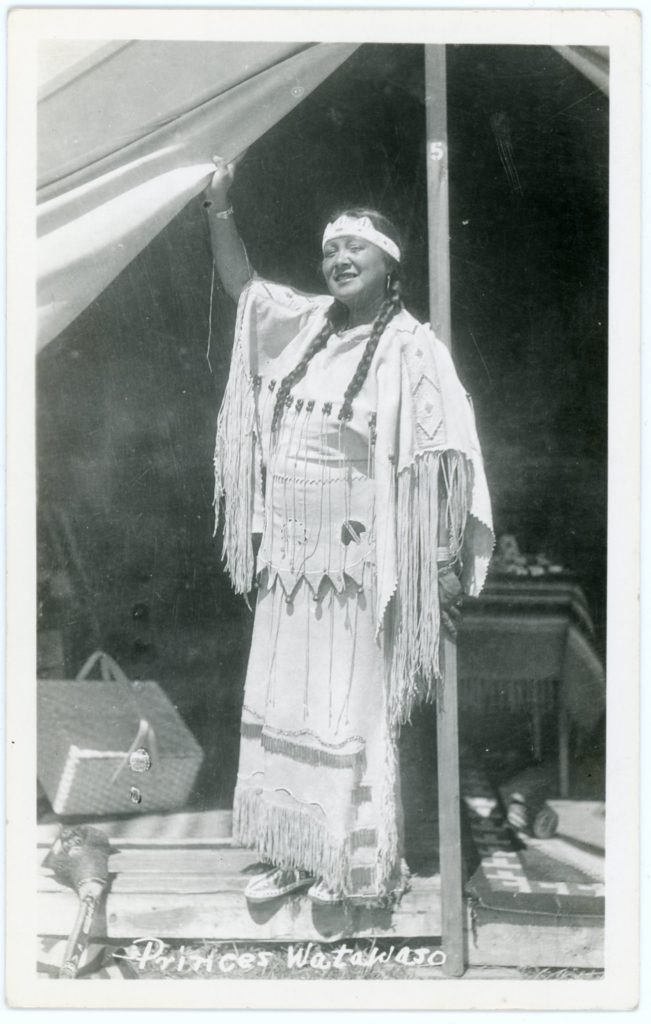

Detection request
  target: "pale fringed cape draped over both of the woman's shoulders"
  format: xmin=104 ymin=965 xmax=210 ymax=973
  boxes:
xmin=215 ymin=279 xmax=494 ymax=725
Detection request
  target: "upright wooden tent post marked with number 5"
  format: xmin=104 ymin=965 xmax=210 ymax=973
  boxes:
xmin=425 ymin=44 xmax=466 ymax=977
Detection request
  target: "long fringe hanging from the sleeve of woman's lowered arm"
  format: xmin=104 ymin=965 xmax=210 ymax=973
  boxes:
xmin=389 ymin=452 xmax=472 ymax=725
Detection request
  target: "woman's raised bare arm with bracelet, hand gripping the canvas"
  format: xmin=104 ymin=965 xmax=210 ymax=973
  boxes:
xmin=204 ymin=157 xmax=253 ymax=302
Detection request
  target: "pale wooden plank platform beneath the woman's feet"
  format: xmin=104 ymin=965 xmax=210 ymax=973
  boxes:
xmin=38 ymin=810 xmax=603 ymax=969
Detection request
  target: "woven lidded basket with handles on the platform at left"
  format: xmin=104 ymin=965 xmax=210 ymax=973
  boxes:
xmin=37 ymin=651 xmax=203 ymax=815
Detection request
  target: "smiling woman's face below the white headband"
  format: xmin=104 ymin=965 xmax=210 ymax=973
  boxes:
xmin=321 ymin=234 xmax=389 ymax=312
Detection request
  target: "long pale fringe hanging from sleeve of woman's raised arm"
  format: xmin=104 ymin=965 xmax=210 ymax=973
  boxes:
xmin=214 ymin=342 xmax=256 ymax=594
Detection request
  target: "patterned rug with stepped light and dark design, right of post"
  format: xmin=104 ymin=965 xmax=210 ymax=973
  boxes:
xmin=461 ymin=754 xmax=604 ymax=918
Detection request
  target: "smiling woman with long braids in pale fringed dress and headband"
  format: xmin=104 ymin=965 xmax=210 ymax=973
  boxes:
xmin=204 ymin=158 xmax=492 ymax=904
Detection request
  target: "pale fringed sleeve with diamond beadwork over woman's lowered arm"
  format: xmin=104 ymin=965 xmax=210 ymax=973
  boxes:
xmin=376 ymin=314 xmax=494 ymax=723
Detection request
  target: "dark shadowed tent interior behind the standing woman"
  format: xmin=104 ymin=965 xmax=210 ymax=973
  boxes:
xmin=37 ymin=45 xmax=608 ymax=807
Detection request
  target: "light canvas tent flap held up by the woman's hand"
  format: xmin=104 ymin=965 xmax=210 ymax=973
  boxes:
xmin=37 ymin=43 xmax=356 ymax=347
